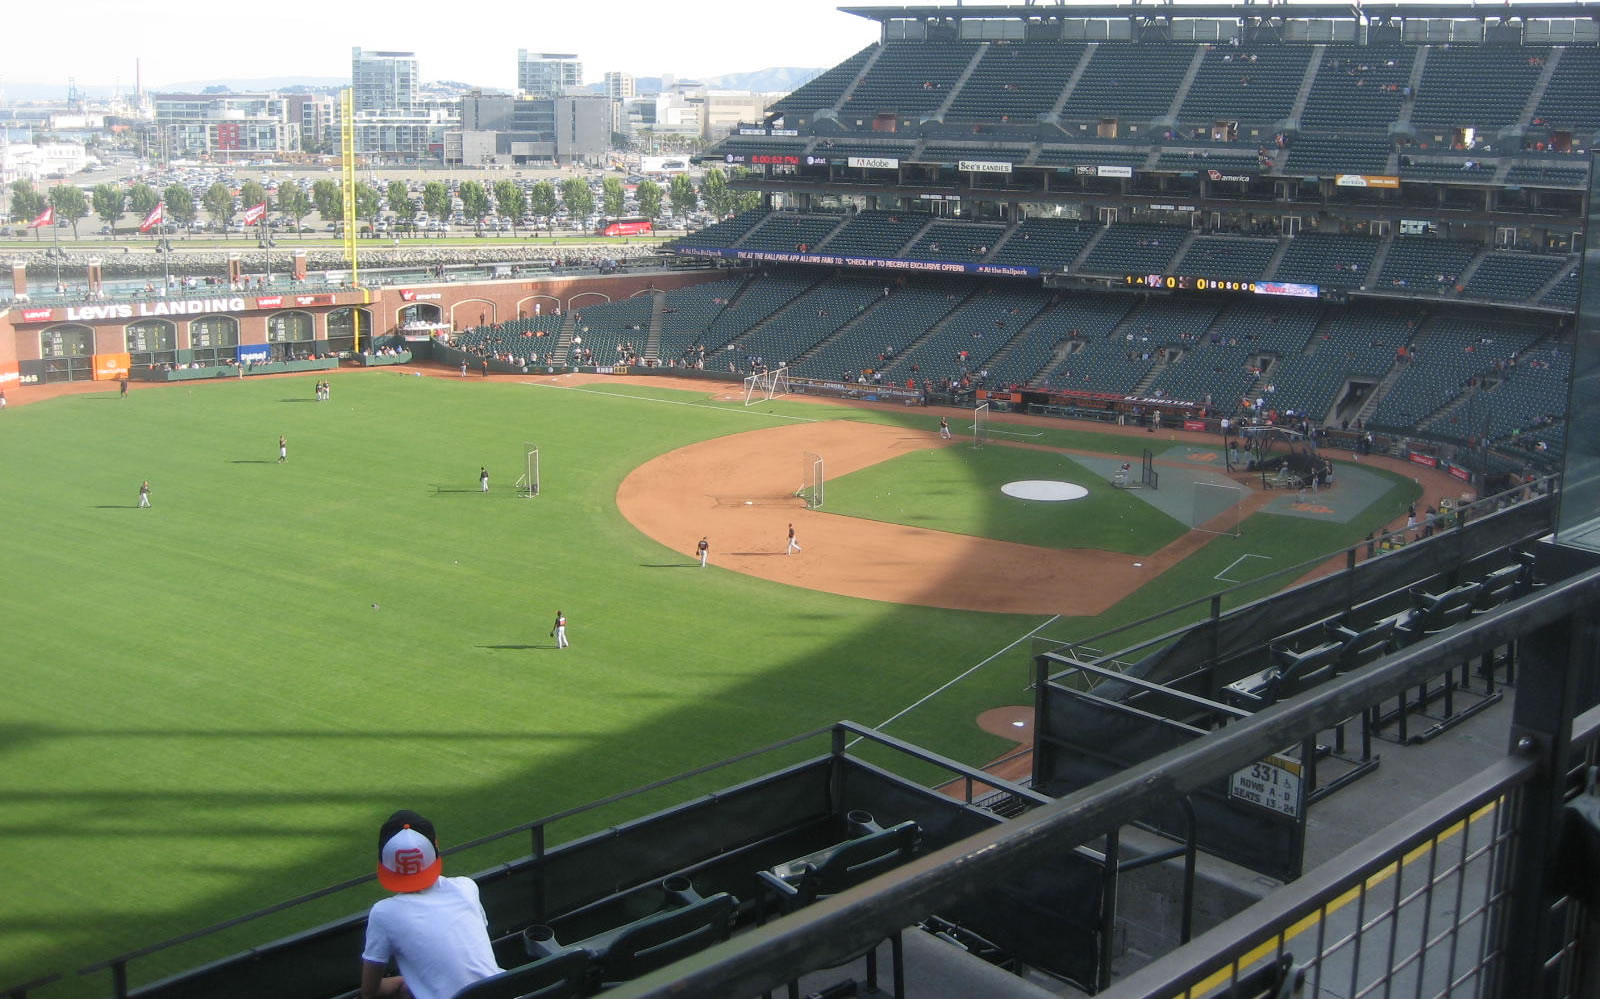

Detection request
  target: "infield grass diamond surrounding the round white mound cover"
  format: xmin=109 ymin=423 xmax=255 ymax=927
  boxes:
xmin=827 ymin=443 xmax=1189 ymax=556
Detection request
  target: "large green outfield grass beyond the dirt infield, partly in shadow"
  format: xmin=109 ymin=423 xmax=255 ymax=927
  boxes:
xmin=0 ymin=371 xmax=1403 ymax=999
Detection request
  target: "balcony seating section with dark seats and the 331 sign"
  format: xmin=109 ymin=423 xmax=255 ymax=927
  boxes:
xmin=1034 ymin=483 xmax=1566 ymax=881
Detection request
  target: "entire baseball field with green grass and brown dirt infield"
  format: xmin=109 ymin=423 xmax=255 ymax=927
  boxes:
xmin=0 ymin=370 xmax=1421 ymax=996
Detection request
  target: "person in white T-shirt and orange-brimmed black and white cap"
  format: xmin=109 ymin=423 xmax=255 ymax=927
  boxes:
xmin=362 ymin=808 xmax=501 ymax=999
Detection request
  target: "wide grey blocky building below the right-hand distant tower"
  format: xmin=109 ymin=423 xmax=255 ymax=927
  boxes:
xmin=443 ymin=93 xmax=613 ymax=167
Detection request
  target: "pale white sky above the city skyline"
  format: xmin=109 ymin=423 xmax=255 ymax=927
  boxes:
xmin=0 ymin=0 xmax=877 ymax=91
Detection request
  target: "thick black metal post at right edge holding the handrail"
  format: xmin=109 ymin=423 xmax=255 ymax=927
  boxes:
xmin=1491 ymin=608 xmax=1600 ymax=997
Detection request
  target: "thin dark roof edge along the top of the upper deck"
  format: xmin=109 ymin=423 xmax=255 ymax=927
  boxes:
xmin=838 ymin=0 xmax=1600 ymax=21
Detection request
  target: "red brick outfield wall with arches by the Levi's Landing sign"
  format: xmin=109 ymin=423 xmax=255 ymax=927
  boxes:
xmin=0 ymin=271 xmax=726 ymax=366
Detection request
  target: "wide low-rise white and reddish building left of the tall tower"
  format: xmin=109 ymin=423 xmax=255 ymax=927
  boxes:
xmin=154 ymin=93 xmax=301 ymax=158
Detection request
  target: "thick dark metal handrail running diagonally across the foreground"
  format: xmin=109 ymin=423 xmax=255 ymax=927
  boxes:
xmin=613 ymin=570 xmax=1600 ymax=999
